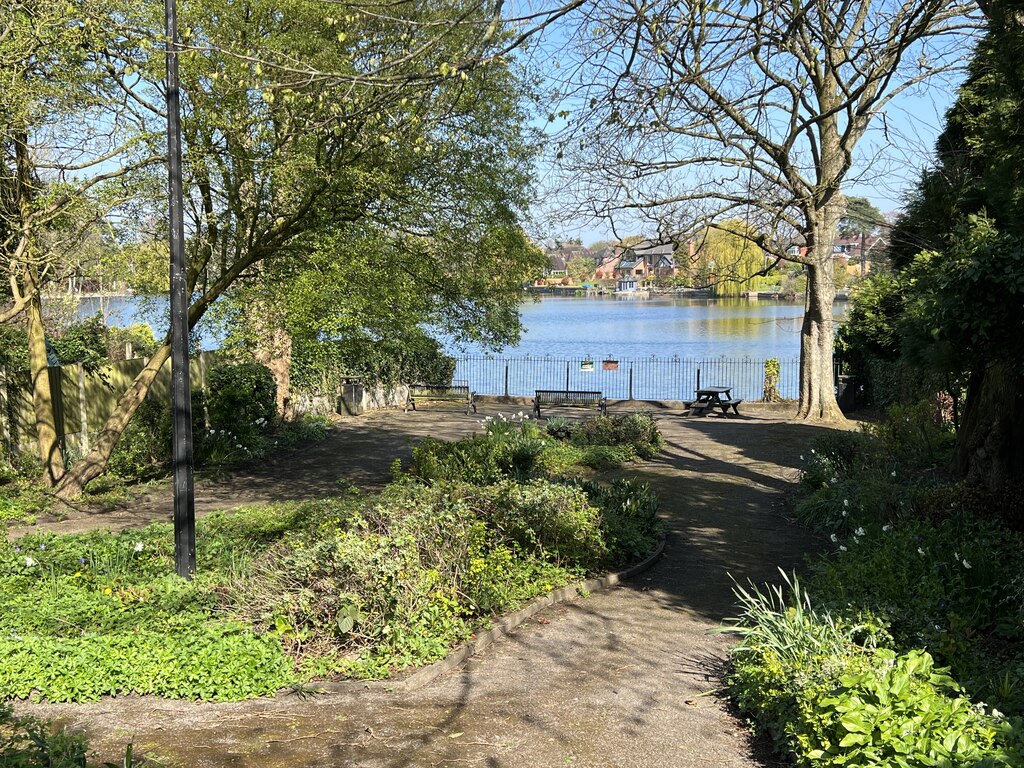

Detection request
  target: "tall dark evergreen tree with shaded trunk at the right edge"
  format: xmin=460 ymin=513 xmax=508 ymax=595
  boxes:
xmin=862 ymin=2 xmax=1024 ymax=492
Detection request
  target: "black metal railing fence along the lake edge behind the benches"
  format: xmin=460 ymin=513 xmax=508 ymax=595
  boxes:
xmin=454 ymin=356 xmax=800 ymax=400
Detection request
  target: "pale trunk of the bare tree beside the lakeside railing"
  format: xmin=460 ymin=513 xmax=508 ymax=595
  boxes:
xmin=797 ymin=230 xmax=846 ymax=422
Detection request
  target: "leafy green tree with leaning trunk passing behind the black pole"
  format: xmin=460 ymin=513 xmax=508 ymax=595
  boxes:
xmin=59 ymin=0 xmax=552 ymax=497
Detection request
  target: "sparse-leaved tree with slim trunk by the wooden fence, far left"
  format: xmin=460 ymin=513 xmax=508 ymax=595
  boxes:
xmin=0 ymin=0 xmax=159 ymax=482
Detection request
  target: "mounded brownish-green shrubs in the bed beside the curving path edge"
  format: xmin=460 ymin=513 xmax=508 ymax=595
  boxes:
xmin=232 ymin=481 xmax=622 ymax=677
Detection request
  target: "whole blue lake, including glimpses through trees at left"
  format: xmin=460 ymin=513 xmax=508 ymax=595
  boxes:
xmin=79 ymin=296 xmax=847 ymax=399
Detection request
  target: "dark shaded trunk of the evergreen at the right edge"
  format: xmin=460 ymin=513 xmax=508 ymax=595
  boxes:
xmin=953 ymin=364 xmax=1024 ymax=493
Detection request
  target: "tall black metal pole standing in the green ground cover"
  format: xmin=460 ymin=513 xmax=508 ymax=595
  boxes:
xmin=164 ymin=0 xmax=196 ymax=579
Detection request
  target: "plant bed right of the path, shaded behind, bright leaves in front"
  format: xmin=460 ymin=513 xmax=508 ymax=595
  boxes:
xmin=728 ymin=407 xmax=1024 ymax=766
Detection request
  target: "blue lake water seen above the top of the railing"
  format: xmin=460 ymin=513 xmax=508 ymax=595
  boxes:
xmin=453 ymin=296 xmax=846 ymax=359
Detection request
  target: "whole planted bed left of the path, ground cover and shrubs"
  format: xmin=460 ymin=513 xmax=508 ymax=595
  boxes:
xmin=0 ymin=415 xmax=660 ymax=701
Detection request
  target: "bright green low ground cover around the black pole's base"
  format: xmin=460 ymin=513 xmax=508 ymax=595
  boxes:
xmin=0 ymin=514 xmax=301 ymax=701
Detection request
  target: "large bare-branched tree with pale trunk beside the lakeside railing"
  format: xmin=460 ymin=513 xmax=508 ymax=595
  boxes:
xmin=557 ymin=0 xmax=973 ymax=420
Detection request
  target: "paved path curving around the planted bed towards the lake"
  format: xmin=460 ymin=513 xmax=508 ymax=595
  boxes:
xmin=19 ymin=405 xmax=831 ymax=768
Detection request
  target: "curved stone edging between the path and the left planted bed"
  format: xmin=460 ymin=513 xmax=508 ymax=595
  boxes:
xmin=303 ymin=537 xmax=667 ymax=693
